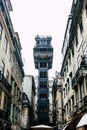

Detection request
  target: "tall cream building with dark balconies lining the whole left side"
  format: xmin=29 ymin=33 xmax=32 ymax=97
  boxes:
xmin=0 ymin=0 xmax=24 ymax=130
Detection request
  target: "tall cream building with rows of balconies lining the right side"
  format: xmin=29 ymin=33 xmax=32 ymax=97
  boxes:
xmin=61 ymin=0 xmax=87 ymax=130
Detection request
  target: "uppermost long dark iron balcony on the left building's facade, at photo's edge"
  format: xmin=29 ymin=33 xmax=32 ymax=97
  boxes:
xmin=0 ymin=71 xmax=12 ymax=94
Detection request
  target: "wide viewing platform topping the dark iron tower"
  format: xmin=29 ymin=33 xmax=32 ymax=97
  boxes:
xmin=33 ymin=35 xmax=53 ymax=69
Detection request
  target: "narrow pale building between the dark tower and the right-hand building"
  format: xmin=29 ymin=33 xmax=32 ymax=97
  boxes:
xmin=52 ymin=72 xmax=64 ymax=130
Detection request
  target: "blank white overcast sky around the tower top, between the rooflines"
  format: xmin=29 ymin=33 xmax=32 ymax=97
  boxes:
xmin=10 ymin=0 xmax=72 ymax=77
